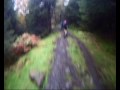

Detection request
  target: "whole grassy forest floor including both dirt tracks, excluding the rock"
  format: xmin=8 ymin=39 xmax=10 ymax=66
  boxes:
xmin=4 ymin=28 xmax=116 ymax=89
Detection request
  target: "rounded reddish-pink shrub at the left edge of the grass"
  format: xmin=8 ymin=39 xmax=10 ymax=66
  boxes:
xmin=13 ymin=33 xmax=40 ymax=55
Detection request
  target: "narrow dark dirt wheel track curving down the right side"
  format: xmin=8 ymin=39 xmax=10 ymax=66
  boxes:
xmin=69 ymin=32 xmax=104 ymax=90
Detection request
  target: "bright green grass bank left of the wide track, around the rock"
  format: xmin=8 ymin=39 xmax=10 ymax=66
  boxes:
xmin=4 ymin=33 xmax=58 ymax=90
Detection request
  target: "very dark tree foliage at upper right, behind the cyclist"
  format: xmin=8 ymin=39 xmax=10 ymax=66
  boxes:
xmin=65 ymin=0 xmax=116 ymax=33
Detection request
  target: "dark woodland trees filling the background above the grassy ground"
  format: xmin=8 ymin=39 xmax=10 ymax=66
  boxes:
xmin=4 ymin=0 xmax=116 ymax=64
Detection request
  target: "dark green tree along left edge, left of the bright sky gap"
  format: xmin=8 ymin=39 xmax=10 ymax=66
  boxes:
xmin=4 ymin=0 xmax=17 ymax=61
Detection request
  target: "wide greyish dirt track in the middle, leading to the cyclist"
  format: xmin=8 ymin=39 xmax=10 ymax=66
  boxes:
xmin=46 ymin=37 xmax=82 ymax=90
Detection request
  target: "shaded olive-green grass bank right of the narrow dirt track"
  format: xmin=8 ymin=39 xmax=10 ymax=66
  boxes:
xmin=70 ymin=28 xmax=116 ymax=88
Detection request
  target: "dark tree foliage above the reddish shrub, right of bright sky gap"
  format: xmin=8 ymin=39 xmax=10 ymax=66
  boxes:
xmin=26 ymin=0 xmax=56 ymax=35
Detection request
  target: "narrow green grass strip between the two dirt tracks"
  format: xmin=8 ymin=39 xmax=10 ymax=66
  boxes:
xmin=68 ymin=37 xmax=94 ymax=90
